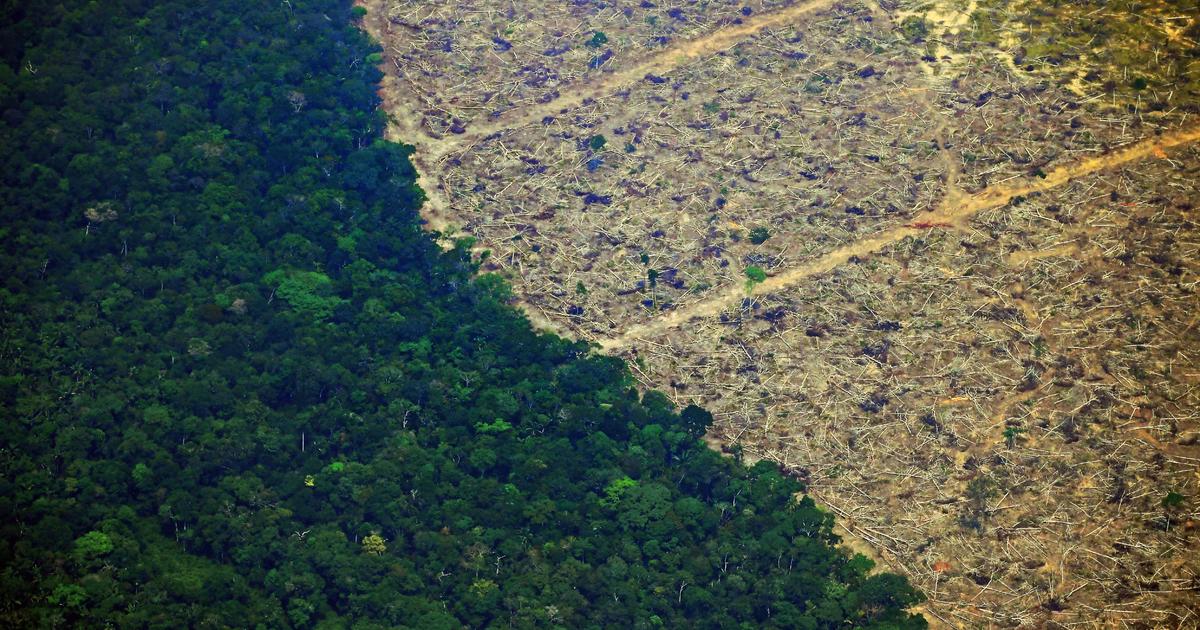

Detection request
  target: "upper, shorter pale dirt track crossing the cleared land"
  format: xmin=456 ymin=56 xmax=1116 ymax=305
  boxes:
xmin=431 ymin=0 xmax=836 ymax=162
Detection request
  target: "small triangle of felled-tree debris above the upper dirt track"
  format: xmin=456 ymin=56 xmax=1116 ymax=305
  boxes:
xmin=374 ymin=0 xmax=806 ymax=136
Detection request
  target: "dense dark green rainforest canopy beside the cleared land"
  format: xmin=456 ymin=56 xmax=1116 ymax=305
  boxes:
xmin=0 ymin=0 xmax=924 ymax=629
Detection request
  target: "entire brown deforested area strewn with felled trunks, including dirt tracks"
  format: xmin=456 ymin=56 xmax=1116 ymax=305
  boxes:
xmin=366 ymin=0 xmax=1200 ymax=626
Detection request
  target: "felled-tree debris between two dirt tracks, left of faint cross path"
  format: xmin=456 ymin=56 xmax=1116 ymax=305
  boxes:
xmin=440 ymin=1 xmax=947 ymax=337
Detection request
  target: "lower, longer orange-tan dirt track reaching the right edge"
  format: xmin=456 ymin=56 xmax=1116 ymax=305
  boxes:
xmin=599 ymin=126 xmax=1200 ymax=352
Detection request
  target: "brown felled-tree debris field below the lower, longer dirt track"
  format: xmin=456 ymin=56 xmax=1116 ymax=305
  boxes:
xmin=626 ymin=152 xmax=1200 ymax=626
